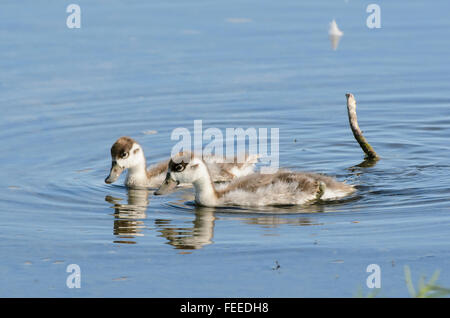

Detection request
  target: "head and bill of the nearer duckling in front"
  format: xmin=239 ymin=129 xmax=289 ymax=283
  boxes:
xmin=154 ymin=153 xmax=209 ymax=195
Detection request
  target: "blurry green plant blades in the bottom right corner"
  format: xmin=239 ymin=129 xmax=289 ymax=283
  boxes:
xmin=404 ymin=266 xmax=450 ymax=298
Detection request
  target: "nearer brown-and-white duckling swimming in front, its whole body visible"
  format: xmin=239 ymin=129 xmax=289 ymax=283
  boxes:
xmin=155 ymin=154 xmax=355 ymax=207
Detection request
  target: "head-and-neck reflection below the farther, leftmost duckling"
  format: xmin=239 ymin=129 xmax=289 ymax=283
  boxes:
xmin=105 ymin=188 xmax=150 ymax=244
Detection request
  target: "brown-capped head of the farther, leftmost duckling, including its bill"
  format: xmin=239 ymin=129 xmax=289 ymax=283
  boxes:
xmin=105 ymin=137 xmax=145 ymax=183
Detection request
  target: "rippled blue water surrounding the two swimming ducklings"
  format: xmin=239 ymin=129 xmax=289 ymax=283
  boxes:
xmin=0 ymin=0 xmax=450 ymax=297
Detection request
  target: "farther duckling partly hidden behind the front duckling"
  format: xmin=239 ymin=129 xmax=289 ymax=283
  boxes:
xmin=105 ymin=137 xmax=258 ymax=188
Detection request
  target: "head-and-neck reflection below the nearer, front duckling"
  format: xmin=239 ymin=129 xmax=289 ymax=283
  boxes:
xmin=155 ymin=208 xmax=216 ymax=250
